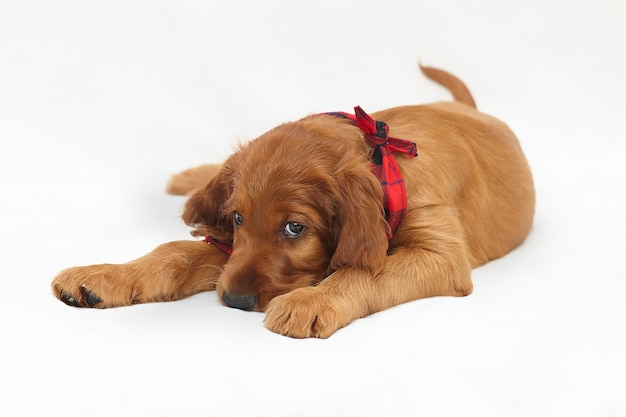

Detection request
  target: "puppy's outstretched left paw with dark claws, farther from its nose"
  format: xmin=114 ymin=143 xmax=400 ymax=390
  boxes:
xmin=52 ymin=264 xmax=132 ymax=308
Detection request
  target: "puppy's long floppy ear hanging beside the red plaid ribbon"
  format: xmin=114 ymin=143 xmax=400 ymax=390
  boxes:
xmin=329 ymin=163 xmax=389 ymax=273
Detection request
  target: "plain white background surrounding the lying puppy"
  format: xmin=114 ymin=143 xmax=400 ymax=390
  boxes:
xmin=0 ymin=0 xmax=626 ymax=417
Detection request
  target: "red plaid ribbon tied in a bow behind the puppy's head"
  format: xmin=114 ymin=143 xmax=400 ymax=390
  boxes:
xmin=326 ymin=106 xmax=417 ymax=239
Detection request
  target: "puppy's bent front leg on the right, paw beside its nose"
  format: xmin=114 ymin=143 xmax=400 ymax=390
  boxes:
xmin=265 ymin=206 xmax=472 ymax=338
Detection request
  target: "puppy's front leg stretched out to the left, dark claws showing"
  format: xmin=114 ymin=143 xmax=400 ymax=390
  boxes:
xmin=52 ymin=241 xmax=228 ymax=308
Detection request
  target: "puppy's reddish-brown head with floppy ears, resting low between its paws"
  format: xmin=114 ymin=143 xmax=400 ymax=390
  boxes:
xmin=183 ymin=116 xmax=388 ymax=311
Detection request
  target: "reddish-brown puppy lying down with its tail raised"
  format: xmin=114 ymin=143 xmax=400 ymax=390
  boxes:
xmin=52 ymin=68 xmax=535 ymax=337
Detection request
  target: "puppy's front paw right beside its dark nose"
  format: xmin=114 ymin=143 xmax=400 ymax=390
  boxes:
xmin=264 ymin=287 xmax=353 ymax=339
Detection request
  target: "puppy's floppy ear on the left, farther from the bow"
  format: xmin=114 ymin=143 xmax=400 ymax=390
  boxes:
xmin=182 ymin=155 xmax=235 ymax=243
